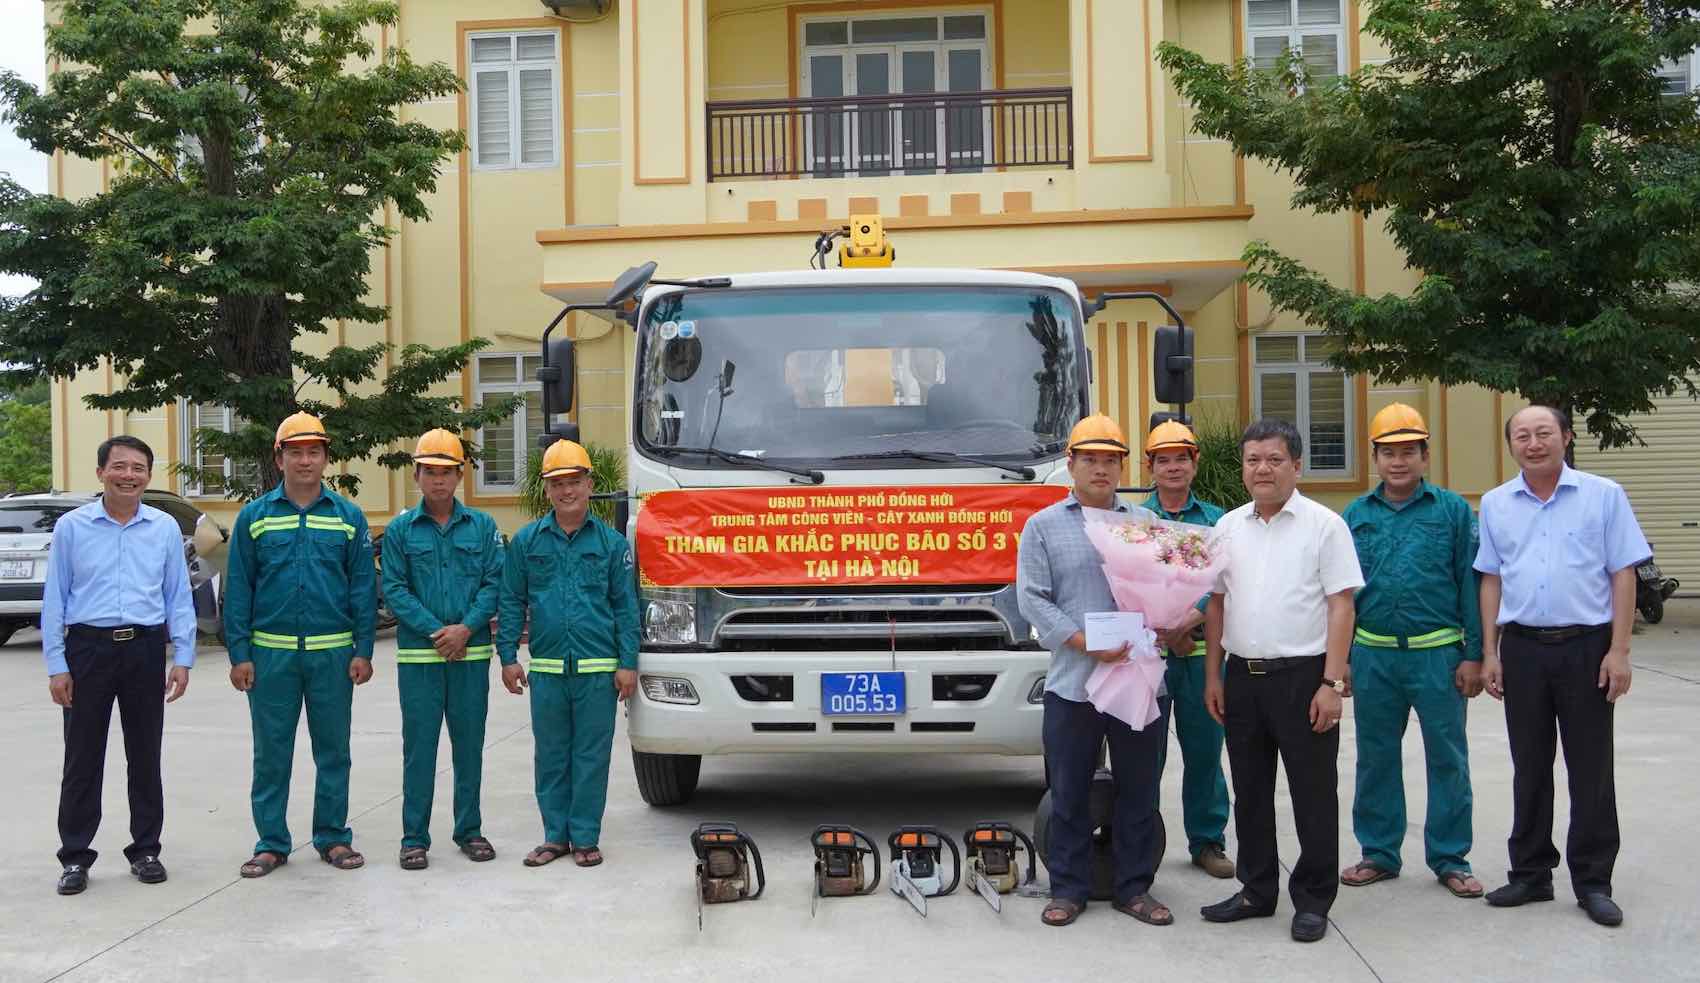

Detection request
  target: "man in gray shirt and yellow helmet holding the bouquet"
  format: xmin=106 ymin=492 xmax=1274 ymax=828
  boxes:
xmin=1015 ymin=415 xmax=1175 ymax=925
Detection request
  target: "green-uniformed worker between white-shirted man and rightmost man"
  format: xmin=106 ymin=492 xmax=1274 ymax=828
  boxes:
xmin=1340 ymin=403 xmax=1482 ymax=898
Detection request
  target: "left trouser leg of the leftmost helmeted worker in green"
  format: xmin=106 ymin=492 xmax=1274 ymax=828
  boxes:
xmin=248 ymin=645 xmax=306 ymax=857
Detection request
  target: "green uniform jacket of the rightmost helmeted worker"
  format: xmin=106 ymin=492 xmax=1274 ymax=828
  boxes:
xmin=1343 ymin=481 xmax=1482 ymax=662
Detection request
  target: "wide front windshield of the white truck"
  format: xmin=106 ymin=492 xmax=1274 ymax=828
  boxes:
xmin=636 ymin=286 xmax=1086 ymax=468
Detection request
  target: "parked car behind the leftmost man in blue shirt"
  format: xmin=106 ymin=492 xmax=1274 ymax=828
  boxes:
xmin=0 ymin=488 xmax=230 ymax=645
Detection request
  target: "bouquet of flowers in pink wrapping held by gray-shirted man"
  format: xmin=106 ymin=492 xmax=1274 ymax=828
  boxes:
xmin=1086 ymin=509 xmax=1227 ymax=730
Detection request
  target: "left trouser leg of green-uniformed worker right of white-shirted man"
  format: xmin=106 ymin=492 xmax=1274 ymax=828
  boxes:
xmin=1352 ymin=645 xmax=1420 ymax=872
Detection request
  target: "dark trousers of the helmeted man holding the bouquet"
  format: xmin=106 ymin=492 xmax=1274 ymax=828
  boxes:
xmin=1044 ymin=692 xmax=1170 ymax=903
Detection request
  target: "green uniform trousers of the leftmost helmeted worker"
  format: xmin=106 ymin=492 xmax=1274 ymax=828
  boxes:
xmin=248 ymin=645 xmax=354 ymax=855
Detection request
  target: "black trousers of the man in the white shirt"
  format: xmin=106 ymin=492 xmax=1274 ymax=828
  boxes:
xmin=1224 ymin=655 xmax=1340 ymax=915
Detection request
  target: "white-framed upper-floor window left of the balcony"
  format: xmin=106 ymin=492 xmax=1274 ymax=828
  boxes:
xmin=468 ymin=31 xmax=561 ymax=170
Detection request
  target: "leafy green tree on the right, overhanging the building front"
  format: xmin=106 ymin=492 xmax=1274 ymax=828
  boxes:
xmin=1158 ymin=0 xmax=1700 ymax=446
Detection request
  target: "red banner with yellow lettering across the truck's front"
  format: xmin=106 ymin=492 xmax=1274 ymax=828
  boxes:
xmin=638 ymin=485 xmax=1068 ymax=587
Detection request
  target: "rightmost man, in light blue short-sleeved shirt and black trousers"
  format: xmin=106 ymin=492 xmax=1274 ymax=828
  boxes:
xmin=1476 ymin=406 xmax=1652 ymax=925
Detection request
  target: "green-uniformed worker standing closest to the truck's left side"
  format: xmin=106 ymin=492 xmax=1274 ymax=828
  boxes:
xmin=496 ymin=440 xmax=638 ymax=867
